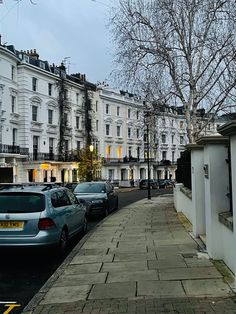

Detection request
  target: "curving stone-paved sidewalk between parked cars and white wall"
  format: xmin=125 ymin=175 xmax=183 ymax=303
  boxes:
xmin=23 ymin=195 xmax=236 ymax=314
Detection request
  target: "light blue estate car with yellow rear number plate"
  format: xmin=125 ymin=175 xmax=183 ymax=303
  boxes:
xmin=0 ymin=184 xmax=87 ymax=251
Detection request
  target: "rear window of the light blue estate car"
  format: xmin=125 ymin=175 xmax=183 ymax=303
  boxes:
xmin=0 ymin=192 xmax=45 ymax=213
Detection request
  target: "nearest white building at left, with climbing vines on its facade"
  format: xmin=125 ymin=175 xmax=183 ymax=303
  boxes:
xmin=0 ymin=45 xmax=93 ymax=182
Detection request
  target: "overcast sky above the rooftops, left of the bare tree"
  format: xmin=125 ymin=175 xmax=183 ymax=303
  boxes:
xmin=0 ymin=0 xmax=114 ymax=83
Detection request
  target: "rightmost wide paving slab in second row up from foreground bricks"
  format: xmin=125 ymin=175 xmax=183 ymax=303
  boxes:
xmin=159 ymin=267 xmax=222 ymax=280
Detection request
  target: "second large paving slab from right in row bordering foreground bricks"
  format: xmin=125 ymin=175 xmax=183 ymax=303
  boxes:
xmin=137 ymin=280 xmax=185 ymax=298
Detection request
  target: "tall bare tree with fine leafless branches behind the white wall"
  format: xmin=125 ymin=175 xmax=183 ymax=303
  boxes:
xmin=110 ymin=0 xmax=236 ymax=142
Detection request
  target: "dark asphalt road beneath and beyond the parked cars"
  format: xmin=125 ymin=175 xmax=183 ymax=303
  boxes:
xmin=0 ymin=189 xmax=172 ymax=314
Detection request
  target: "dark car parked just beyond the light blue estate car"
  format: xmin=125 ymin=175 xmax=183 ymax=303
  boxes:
xmin=74 ymin=181 xmax=118 ymax=216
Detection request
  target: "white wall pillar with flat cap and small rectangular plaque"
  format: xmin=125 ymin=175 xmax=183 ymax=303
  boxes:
xmin=198 ymin=136 xmax=229 ymax=259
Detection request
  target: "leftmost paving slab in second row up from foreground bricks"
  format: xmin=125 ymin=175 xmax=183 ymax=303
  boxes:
xmin=54 ymin=273 xmax=107 ymax=287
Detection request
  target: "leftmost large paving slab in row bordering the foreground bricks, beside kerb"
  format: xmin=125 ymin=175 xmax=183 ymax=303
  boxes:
xmin=40 ymin=285 xmax=92 ymax=304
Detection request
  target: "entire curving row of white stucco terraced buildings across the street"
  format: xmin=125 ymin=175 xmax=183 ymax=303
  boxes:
xmin=0 ymin=40 xmax=227 ymax=186
